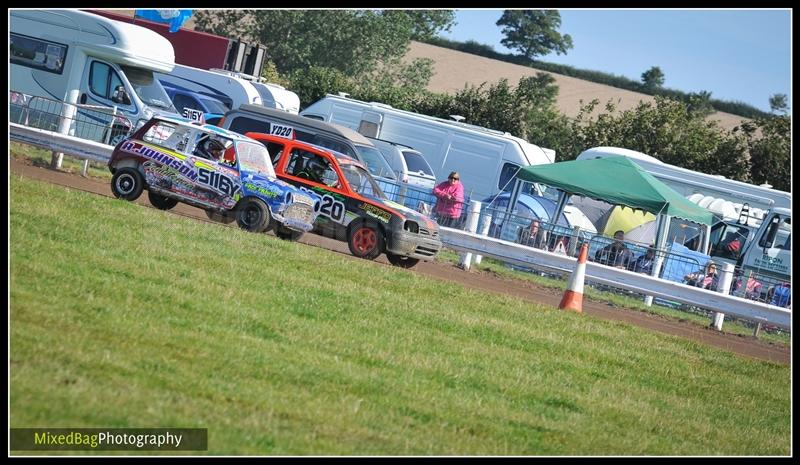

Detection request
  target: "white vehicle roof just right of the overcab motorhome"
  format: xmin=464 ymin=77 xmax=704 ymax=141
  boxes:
xmin=156 ymin=64 xmax=262 ymax=108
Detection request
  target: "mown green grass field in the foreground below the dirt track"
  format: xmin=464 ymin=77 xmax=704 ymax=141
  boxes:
xmin=9 ymin=175 xmax=791 ymax=455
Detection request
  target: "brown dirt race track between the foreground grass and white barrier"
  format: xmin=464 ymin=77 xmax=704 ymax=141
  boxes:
xmin=9 ymin=159 xmax=791 ymax=364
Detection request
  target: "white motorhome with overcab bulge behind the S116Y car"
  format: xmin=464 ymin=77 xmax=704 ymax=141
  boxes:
xmin=9 ymin=10 xmax=175 ymax=143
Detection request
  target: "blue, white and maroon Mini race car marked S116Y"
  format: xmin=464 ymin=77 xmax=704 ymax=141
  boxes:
xmin=108 ymin=116 xmax=320 ymax=240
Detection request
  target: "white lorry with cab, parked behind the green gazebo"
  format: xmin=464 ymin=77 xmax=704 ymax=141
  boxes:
xmin=577 ymin=147 xmax=792 ymax=292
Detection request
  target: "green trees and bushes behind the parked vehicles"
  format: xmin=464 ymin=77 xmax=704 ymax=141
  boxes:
xmin=195 ymin=10 xmax=791 ymax=191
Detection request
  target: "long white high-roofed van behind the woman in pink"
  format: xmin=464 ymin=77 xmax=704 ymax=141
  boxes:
xmin=300 ymin=94 xmax=555 ymax=199
